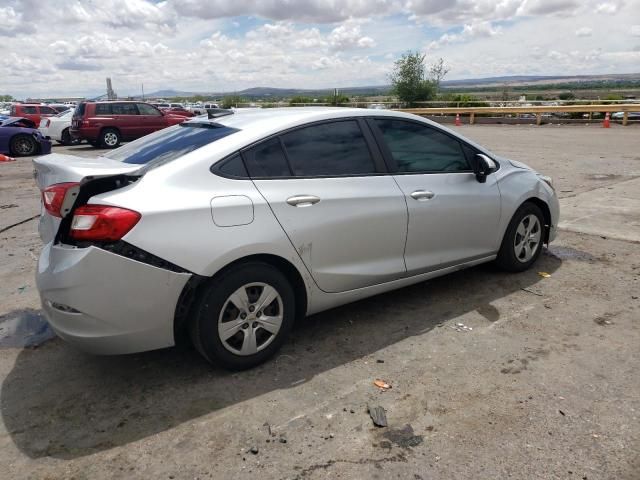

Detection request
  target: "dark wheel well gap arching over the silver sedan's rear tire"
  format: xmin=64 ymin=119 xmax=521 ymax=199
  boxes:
xmin=173 ymin=254 xmax=307 ymax=342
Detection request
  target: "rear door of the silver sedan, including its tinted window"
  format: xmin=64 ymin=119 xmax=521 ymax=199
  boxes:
xmin=248 ymin=119 xmax=407 ymax=292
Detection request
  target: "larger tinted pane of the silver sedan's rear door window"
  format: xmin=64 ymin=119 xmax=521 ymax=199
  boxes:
xmin=282 ymin=120 xmax=376 ymax=177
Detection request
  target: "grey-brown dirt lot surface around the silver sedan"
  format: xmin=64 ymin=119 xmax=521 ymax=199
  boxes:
xmin=0 ymin=125 xmax=640 ymax=480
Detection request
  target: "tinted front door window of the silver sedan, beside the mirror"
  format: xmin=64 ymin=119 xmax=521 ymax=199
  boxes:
xmin=375 ymin=119 xmax=471 ymax=173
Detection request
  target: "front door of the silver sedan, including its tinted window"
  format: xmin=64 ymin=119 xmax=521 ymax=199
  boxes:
xmin=370 ymin=117 xmax=500 ymax=275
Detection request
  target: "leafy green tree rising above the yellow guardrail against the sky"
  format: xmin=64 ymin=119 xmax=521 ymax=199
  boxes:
xmin=389 ymin=52 xmax=438 ymax=107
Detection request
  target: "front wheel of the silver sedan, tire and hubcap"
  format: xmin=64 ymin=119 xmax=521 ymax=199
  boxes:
xmin=496 ymin=202 xmax=545 ymax=272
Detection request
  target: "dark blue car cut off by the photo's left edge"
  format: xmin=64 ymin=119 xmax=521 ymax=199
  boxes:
xmin=0 ymin=117 xmax=51 ymax=157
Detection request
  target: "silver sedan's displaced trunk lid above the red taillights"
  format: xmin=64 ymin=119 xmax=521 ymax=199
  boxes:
xmin=33 ymin=153 xmax=141 ymax=243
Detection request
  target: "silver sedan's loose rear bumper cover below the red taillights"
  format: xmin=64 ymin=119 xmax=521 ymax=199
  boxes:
xmin=36 ymin=243 xmax=191 ymax=355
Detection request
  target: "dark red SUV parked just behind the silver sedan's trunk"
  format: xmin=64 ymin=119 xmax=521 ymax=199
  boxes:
xmin=70 ymin=101 xmax=185 ymax=148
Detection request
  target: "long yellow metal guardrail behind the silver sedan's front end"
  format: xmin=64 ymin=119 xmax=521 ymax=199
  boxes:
xmin=398 ymin=103 xmax=640 ymax=125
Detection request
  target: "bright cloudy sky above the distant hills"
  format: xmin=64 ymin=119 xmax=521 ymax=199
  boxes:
xmin=0 ymin=0 xmax=640 ymax=98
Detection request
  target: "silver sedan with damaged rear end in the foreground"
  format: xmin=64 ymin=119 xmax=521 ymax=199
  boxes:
xmin=34 ymin=108 xmax=559 ymax=369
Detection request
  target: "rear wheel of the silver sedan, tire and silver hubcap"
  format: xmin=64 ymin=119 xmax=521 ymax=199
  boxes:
xmin=189 ymin=262 xmax=296 ymax=370
